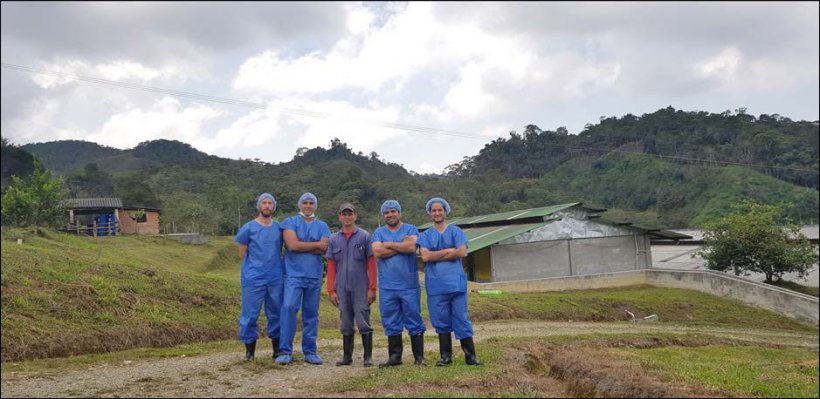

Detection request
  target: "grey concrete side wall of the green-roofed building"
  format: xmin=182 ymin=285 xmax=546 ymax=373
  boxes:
xmin=491 ymin=235 xmax=652 ymax=282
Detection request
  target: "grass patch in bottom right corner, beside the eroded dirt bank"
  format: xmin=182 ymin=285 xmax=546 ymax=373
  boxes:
xmin=611 ymin=346 xmax=819 ymax=398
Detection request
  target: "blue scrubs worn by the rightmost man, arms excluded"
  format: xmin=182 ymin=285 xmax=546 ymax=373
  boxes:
xmin=416 ymin=225 xmax=473 ymax=340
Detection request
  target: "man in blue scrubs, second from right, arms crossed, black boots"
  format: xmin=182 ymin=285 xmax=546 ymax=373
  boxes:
xmin=372 ymin=200 xmax=427 ymax=367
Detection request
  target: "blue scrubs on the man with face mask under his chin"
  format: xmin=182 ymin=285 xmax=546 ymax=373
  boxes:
xmin=279 ymin=216 xmax=330 ymax=355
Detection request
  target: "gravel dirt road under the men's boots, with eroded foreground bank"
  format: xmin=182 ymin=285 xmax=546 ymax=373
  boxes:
xmin=2 ymin=320 xmax=818 ymax=397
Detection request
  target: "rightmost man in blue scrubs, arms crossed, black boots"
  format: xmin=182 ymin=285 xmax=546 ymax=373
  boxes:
xmin=417 ymin=197 xmax=481 ymax=366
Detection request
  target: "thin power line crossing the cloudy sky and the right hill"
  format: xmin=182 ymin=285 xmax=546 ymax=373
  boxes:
xmin=0 ymin=63 xmax=818 ymax=173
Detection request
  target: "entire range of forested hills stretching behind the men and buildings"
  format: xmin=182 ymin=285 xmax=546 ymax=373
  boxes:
xmin=14 ymin=108 xmax=819 ymax=233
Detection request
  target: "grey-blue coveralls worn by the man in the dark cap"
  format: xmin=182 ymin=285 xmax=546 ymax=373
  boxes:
xmin=325 ymin=227 xmax=373 ymax=335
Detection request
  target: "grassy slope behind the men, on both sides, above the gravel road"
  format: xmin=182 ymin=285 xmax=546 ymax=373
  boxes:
xmin=1 ymin=229 xmax=817 ymax=361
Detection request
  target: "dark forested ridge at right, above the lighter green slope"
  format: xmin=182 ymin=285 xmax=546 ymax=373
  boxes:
xmin=451 ymin=107 xmax=820 ymax=189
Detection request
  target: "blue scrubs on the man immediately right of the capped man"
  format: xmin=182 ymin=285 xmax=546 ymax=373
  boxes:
xmin=372 ymin=223 xmax=427 ymax=337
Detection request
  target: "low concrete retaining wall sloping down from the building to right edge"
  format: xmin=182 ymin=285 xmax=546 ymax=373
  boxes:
xmin=477 ymin=269 xmax=820 ymax=325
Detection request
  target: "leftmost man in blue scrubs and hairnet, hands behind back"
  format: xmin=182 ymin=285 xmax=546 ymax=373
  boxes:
xmin=235 ymin=193 xmax=282 ymax=360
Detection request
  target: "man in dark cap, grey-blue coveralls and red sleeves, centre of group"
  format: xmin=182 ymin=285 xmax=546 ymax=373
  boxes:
xmin=325 ymin=203 xmax=376 ymax=367
